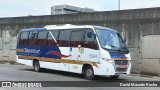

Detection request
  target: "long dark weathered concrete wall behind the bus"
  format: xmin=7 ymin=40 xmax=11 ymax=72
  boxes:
xmin=0 ymin=8 xmax=160 ymax=73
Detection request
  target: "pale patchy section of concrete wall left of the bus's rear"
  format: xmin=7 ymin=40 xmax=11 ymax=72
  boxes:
xmin=0 ymin=30 xmax=17 ymax=61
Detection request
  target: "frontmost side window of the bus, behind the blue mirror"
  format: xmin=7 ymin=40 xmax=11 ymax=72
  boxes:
xmin=83 ymin=29 xmax=98 ymax=50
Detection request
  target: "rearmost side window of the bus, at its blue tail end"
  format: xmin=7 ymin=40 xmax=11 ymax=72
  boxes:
xmin=19 ymin=32 xmax=29 ymax=46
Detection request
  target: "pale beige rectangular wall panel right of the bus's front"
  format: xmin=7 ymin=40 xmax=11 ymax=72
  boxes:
xmin=140 ymin=35 xmax=160 ymax=75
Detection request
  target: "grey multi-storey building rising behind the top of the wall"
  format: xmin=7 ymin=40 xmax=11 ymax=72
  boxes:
xmin=51 ymin=5 xmax=95 ymax=15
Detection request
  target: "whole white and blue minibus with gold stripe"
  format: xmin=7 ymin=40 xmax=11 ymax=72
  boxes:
xmin=17 ymin=25 xmax=131 ymax=80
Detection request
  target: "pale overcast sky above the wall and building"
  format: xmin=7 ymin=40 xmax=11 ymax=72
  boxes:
xmin=0 ymin=0 xmax=160 ymax=17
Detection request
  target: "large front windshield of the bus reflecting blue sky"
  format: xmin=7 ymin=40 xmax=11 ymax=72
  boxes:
xmin=96 ymin=28 xmax=129 ymax=53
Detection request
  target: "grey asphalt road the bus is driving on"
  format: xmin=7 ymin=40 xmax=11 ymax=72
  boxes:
xmin=0 ymin=64 xmax=160 ymax=90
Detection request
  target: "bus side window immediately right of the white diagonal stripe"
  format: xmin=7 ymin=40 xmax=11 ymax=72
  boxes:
xmin=58 ymin=30 xmax=70 ymax=47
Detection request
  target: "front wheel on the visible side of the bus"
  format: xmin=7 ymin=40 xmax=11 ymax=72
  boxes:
xmin=84 ymin=66 xmax=94 ymax=80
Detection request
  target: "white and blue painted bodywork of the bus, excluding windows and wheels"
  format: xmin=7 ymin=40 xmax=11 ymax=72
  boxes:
xmin=17 ymin=25 xmax=131 ymax=76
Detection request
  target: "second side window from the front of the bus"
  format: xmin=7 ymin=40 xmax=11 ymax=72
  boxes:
xmin=70 ymin=30 xmax=84 ymax=47
